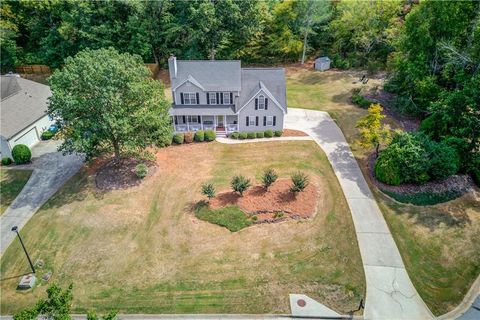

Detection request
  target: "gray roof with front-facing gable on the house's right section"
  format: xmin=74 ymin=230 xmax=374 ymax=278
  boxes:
xmin=239 ymin=68 xmax=287 ymax=112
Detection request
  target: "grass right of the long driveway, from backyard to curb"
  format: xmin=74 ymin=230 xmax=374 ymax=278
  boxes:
xmin=287 ymin=68 xmax=480 ymax=315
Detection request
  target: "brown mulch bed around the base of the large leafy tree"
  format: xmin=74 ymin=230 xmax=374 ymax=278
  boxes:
xmin=95 ymin=158 xmax=157 ymax=191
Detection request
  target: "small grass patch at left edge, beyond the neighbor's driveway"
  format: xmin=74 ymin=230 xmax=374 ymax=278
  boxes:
xmin=0 ymin=169 xmax=32 ymax=215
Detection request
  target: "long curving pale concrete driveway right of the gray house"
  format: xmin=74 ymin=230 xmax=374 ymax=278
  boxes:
xmin=285 ymin=108 xmax=433 ymax=320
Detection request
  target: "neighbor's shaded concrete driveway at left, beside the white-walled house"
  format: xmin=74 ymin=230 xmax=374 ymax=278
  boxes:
xmin=0 ymin=140 xmax=83 ymax=256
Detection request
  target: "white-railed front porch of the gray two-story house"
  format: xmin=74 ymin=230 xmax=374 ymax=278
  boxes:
xmin=172 ymin=115 xmax=238 ymax=134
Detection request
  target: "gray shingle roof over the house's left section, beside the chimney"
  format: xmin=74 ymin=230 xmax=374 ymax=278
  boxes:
xmin=169 ymin=60 xmax=241 ymax=91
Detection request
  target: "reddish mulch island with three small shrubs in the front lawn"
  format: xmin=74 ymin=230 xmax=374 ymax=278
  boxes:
xmin=210 ymin=179 xmax=318 ymax=223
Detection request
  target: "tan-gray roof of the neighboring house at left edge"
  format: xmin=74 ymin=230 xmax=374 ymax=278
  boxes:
xmin=0 ymin=76 xmax=52 ymax=139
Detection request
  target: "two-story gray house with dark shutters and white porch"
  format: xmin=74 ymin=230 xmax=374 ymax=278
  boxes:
xmin=168 ymin=57 xmax=287 ymax=136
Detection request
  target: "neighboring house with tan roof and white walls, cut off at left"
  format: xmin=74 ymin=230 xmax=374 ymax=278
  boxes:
xmin=0 ymin=75 xmax=53 ymax=157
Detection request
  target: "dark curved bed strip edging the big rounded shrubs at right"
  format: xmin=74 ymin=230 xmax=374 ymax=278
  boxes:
xmin=367 ymin=153 xmax=475 ymax=194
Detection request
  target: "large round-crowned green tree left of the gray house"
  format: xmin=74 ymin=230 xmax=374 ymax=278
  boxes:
xmin=48 ymin=48 xmax=172 ymax=160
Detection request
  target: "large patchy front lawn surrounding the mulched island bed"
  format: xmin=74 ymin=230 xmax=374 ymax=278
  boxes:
xmin=0 ymin=141 xmax=365 ymax=314
